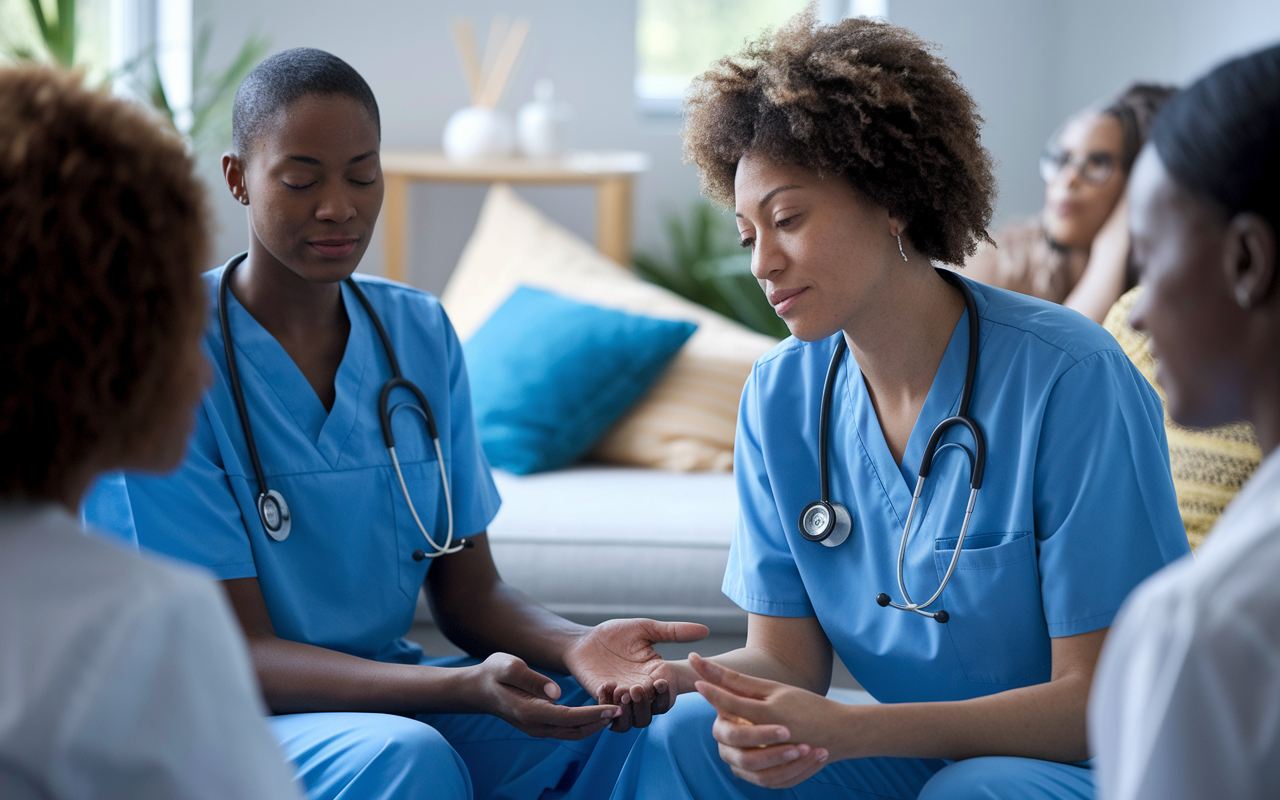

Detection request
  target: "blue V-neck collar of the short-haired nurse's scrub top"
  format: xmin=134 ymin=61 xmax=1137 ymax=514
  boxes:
xmin=227 ymin=272 xmax=375 ymax=467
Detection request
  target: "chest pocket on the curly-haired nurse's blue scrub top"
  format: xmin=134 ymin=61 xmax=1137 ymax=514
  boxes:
xmin=933 ymin=531 xmax=1051 ymax=685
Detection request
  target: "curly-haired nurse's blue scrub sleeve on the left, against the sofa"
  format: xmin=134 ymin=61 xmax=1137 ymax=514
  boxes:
xmin=721 ymin=369 xmax=814 ymax=617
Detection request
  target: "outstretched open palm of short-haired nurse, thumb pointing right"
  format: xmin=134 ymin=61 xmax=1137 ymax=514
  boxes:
xmin=564 ymin=620 xmax=710 ymax=731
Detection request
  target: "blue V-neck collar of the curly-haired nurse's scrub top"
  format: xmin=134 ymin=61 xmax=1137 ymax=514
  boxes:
xmin=845 ymin=284 xmax=984 ymax=525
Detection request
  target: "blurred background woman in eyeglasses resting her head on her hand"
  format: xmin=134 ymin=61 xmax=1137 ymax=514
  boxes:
xmin=965 ymin=83 xmax=1174 ymax=323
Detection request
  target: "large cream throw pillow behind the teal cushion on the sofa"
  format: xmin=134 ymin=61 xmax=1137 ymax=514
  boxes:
xmin=440 ymin=184 xmax=777 ymax=471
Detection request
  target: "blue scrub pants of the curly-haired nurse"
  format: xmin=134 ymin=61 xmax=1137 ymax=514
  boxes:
xmin=612 ymin=694 xmax=1093 ymax=800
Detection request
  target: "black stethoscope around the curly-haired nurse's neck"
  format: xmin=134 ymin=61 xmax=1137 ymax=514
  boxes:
xmin=800 ymin=269 xmax=987 ymax=622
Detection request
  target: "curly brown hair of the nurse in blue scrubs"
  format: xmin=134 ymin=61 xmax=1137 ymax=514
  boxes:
xmin=682 ymin=8 xmax=996 ymax=265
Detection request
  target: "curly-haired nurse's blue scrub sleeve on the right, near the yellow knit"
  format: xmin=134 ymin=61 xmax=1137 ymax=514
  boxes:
xmin=1029 ymin=351 xmax=1190 ymax=637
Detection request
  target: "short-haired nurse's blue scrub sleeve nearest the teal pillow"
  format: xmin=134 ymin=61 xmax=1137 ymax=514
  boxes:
xmin=440 ymin=308 xmax=502 ymax=538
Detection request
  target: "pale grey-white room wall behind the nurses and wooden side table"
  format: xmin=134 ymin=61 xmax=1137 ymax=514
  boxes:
xmin=196 ymin=0 xmax=1280 ymax=291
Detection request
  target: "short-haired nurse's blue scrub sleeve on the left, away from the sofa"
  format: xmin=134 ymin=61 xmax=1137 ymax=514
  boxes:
xmin=124 ymin=396 xmax=257 ymax=581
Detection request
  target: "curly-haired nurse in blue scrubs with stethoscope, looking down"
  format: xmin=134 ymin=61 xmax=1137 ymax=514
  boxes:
xmin=613 ymin=13 xmax=1188 ymax=799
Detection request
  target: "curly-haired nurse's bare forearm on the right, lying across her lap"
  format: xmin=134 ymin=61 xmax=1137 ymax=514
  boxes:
xmin=831 ymin=676 xmax=1089 ymax=762
